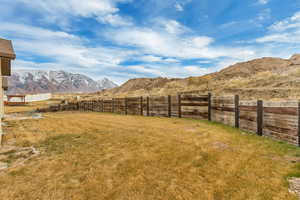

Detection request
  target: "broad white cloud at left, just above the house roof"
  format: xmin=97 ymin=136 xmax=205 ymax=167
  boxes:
xmin=0 ymin=23 xmax=135 ymax=68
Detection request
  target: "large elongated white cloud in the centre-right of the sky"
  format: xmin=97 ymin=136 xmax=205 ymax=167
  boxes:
xmin=104 ymin=23 xmax=254 ymax=59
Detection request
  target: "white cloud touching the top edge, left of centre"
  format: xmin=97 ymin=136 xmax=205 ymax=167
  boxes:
xmin=17 ymin=0 xmax=132 ymax=25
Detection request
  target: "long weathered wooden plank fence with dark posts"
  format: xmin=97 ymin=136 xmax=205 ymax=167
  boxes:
xmin=38 ymin=94 xmax=300 ymax=146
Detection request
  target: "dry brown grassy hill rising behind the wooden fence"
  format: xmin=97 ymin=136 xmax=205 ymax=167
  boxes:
xmin=99 ymin=54 xmax=300 ymax=99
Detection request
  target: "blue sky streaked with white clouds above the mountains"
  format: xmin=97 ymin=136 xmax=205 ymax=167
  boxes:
xmin=0 ymin=0 xmax=300 ymax=84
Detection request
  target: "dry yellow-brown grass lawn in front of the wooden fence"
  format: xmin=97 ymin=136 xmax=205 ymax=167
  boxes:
xmin=0 ymin=112 xmax=300 ymax=200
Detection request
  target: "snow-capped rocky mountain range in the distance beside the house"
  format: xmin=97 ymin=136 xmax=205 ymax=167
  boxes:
xmin=8 ymin=70 xmax=118 ymax=94
